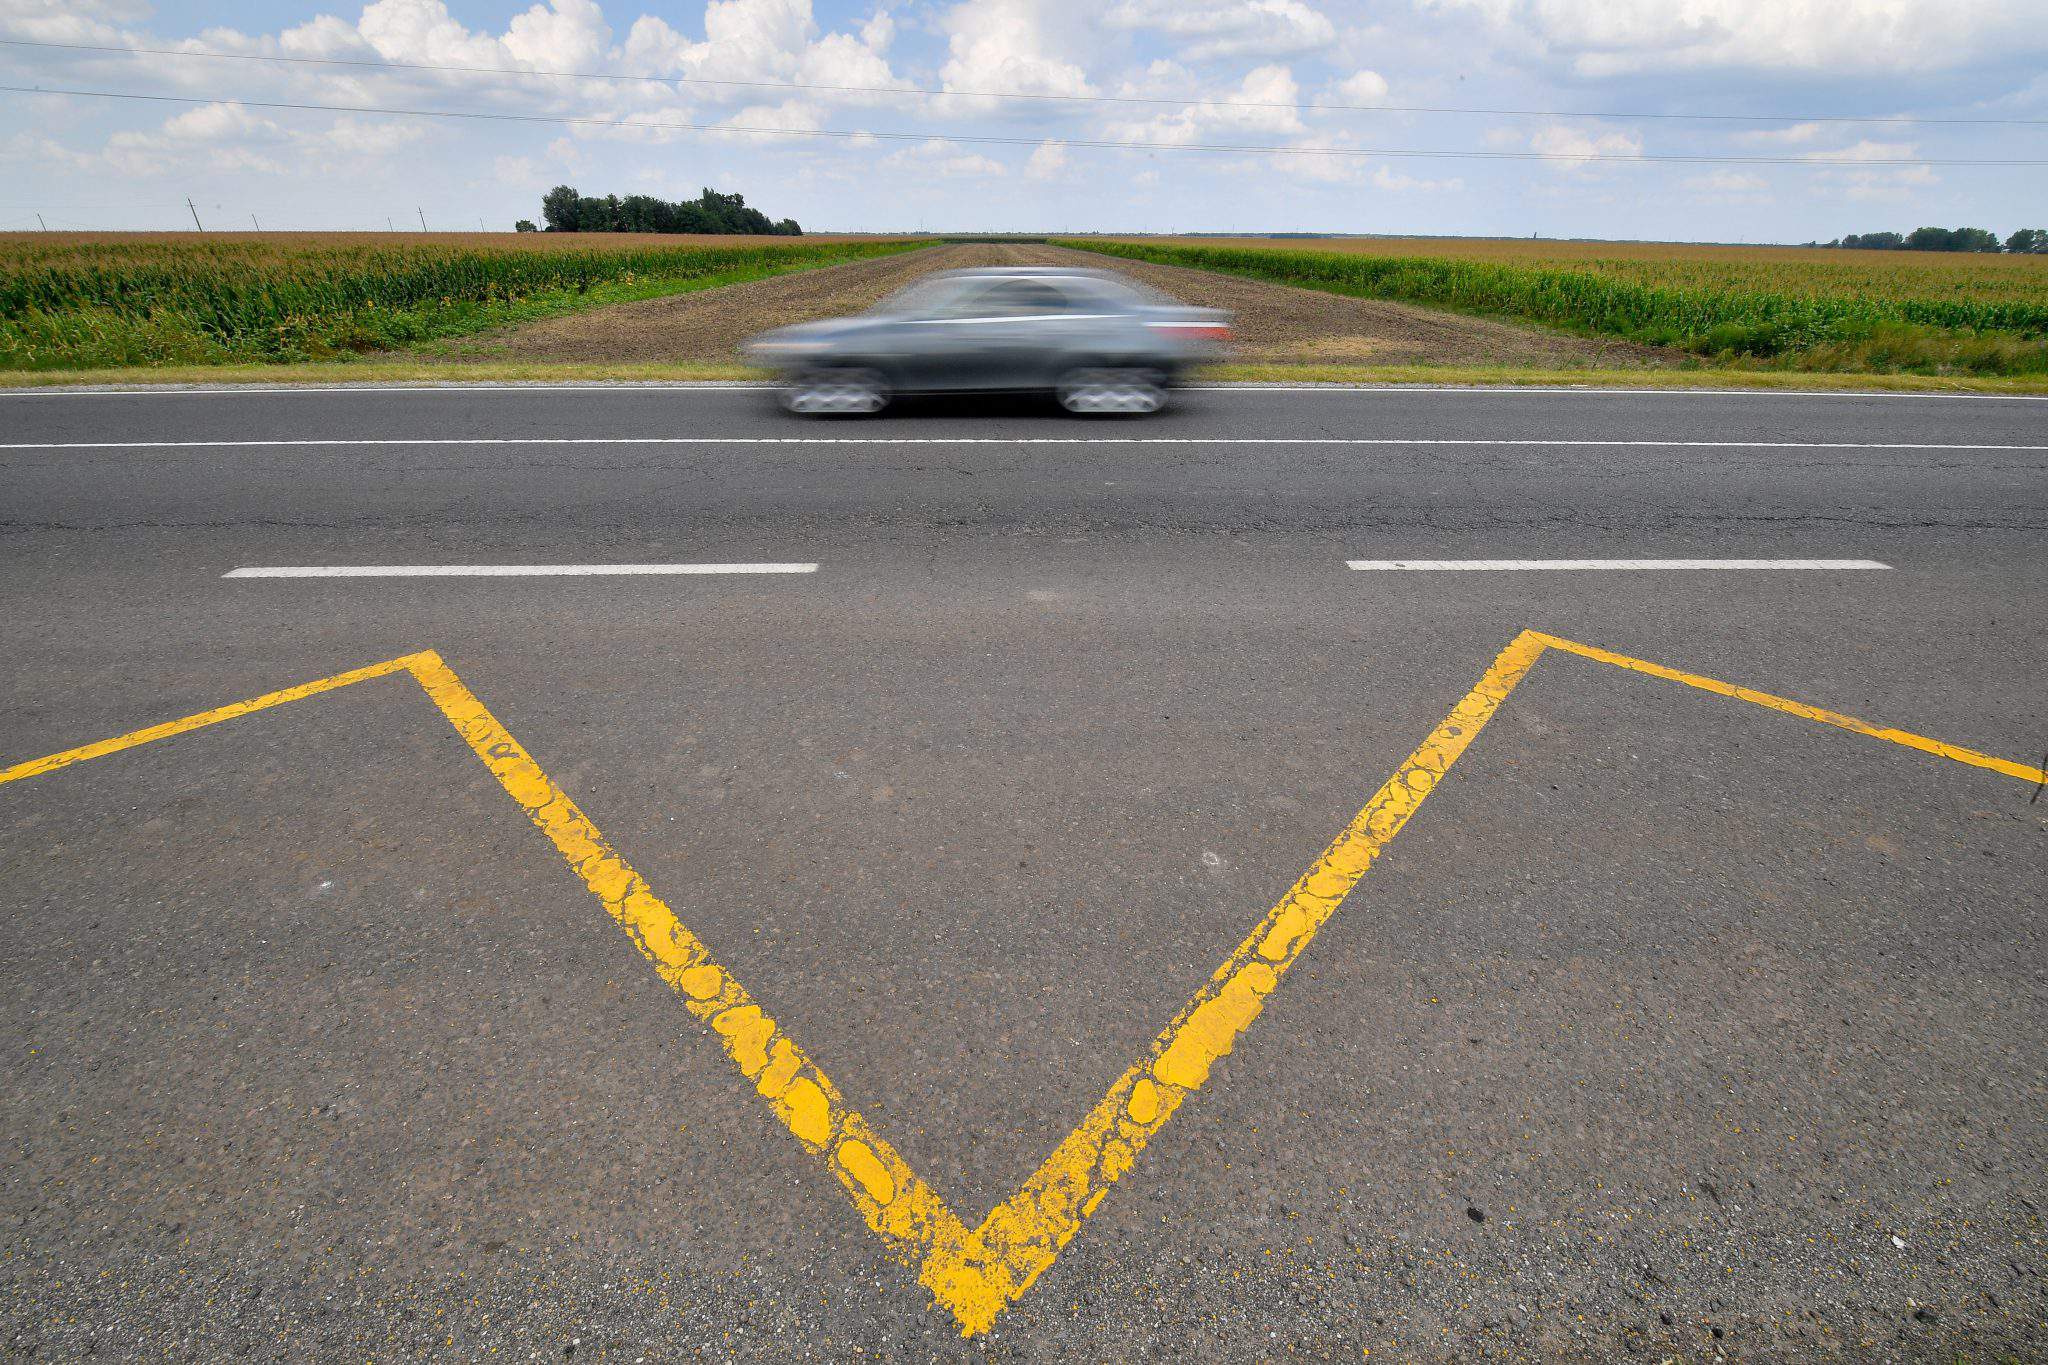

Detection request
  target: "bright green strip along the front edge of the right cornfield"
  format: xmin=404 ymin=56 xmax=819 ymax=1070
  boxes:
xmin=1059 ymin=239 xmax=2048 ymax=375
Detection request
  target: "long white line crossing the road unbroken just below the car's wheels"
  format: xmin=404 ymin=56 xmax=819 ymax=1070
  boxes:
xmin=0 ymin=436 xmax=2048 ymax=452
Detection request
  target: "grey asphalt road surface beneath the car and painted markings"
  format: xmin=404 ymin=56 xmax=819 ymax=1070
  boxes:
xmin=0 ymin=389 xmax=2048 ymax=1361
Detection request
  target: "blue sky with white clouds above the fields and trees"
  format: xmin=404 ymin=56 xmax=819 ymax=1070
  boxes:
xmin=0 ymin=0 xmax=2048 ymax=241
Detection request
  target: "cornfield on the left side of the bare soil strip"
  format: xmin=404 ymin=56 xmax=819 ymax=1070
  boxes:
xmin=0 ymin=233 xmax=913 ymax=368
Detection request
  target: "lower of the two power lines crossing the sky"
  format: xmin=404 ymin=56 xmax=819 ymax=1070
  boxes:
xmin=0 ymin=86 xmax=2048 ymax=168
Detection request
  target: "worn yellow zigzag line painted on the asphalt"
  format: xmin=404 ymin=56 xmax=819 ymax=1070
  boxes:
xmin=0 ymin=630 xmax=2042 ymax=1336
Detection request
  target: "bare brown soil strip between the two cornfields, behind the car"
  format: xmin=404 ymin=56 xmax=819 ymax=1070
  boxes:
xmin=451 ymin=244 xmax=1669 ymax=368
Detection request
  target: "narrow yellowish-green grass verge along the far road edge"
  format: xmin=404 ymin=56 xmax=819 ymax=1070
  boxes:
xmin=0 ymin=358 xmax=2048 ymax=395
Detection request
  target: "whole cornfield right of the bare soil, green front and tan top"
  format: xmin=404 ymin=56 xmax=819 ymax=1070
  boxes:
xmin=1061 ymin=237 xmax=2048 ymax=370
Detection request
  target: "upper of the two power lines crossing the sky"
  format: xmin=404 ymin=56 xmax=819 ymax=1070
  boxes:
xmin=0 ymin=39 xmax=2048 ymax=127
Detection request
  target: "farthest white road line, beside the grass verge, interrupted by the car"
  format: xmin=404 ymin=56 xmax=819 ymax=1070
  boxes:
xmin=0 ymin=379 xmax=2048 ymax=403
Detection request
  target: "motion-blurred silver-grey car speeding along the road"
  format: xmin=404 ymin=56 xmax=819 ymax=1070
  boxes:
xmin=745 ymin=266 xmax=1231 ymax=413
